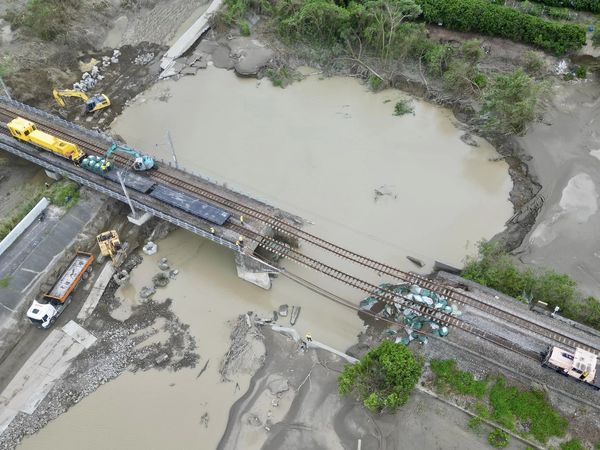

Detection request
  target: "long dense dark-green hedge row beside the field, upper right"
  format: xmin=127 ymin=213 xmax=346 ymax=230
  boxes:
xmin=418 ymin=0 xmax=586 ymax=54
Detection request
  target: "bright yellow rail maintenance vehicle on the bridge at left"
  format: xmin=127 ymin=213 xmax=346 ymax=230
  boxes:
xmin=7 ymin=117 xmax=85 ymax=164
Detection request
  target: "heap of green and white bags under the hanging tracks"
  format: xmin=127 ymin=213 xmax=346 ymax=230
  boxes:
xmin=360 ymin=283 xmax=462 ymax=345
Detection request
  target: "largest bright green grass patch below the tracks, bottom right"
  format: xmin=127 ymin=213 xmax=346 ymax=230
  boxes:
xmin=490 ymin=378 xmax=569 ymax=443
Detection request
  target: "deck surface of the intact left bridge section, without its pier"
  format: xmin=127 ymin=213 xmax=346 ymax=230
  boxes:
xmin=0 ymin=97 xmax=298 ymax=253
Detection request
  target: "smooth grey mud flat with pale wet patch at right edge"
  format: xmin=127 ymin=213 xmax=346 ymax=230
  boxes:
xmin=519 ymin=80 xmax=600 ymax=297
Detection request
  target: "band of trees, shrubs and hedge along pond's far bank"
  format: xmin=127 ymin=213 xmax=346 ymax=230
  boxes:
xmin=213 ymin=0 xmax=586 ymax=135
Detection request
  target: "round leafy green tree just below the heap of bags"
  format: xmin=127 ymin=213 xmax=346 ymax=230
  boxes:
xmin=338 ymin=341 xmax=422 ymax=413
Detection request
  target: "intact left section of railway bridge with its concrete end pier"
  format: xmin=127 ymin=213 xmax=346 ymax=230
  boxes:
xmin=0 ymin=97 xmax=299 ymax=289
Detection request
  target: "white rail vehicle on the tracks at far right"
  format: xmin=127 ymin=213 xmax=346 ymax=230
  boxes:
xmin=542 ymin=346 xmax=600 ymax=390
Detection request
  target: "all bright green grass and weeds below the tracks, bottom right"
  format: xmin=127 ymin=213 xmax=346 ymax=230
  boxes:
xmin=430 ymin=359 xmax=568 ymax=448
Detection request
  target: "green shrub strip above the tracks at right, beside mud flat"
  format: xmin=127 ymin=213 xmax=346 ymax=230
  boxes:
xmin=462 ymin=242 xmax=600 ymax=330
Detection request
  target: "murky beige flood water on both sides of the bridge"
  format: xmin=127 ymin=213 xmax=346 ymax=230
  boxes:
xmin=22 ymin=65 xmax=512 ymax=450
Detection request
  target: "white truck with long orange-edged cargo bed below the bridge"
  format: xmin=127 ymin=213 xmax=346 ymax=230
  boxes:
xmin=27 ymin=252 xmax=94 ymax=328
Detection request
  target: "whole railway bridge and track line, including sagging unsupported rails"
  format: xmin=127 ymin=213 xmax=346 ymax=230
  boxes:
xmin=0 ymin=97 xmax=600 ymax=380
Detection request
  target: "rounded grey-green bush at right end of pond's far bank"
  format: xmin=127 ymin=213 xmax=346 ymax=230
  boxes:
xmin=482 ymin=69 xmax=548 ymax=134
